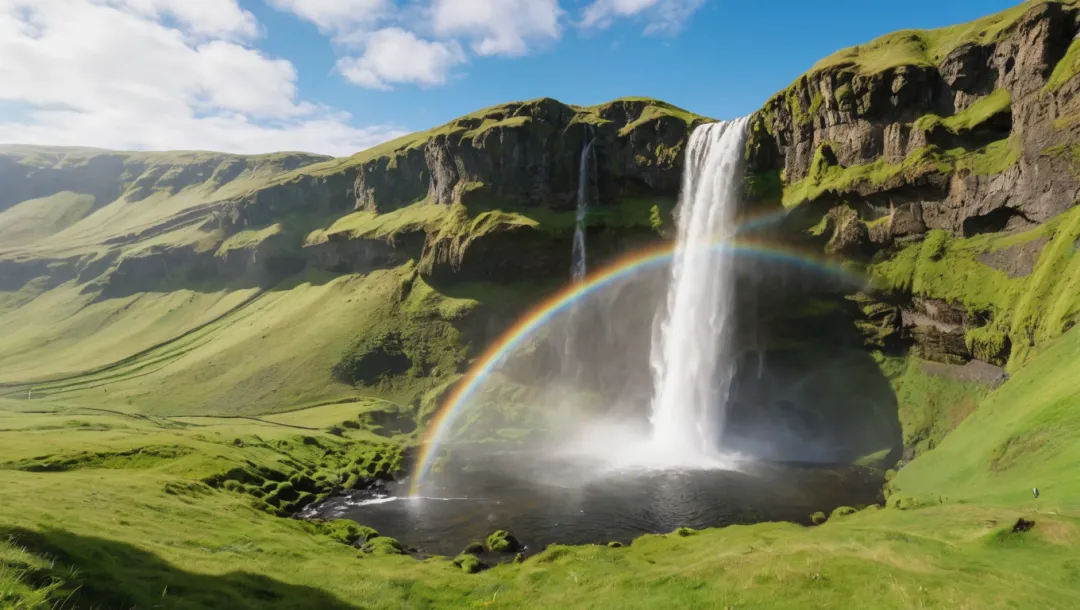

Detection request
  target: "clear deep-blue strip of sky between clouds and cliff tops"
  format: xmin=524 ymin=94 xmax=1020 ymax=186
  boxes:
xmin=243 ymin=0 xmax=1015 ymax=130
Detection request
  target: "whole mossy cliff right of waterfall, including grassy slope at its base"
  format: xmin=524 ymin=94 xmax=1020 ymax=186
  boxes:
xmin=746 ymin=1 xmax=1080 ymax=449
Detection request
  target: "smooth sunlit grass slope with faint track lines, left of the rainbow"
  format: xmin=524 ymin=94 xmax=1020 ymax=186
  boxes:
xmin=0 ymin=266 xmax=475 ymax=415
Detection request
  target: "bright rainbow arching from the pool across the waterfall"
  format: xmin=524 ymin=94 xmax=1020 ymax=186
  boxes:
xmin=409 ymin=237 xmax=863 ymax=497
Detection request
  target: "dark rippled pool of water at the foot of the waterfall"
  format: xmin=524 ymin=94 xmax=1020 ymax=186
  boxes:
xmin=303 ymin=456 xmax=882 ymax=555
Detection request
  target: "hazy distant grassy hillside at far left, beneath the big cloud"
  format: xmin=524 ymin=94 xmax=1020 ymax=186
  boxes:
xmin=0 ymin=146 xmax=327 ymax=258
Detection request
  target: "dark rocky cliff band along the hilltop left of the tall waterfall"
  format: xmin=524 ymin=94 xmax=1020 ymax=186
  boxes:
xmin=353 ymin=98 xmax=704 ymax=212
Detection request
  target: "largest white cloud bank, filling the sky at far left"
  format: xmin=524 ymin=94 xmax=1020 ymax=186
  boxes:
xmin=0 ymin=0 xmax=399 ymax=154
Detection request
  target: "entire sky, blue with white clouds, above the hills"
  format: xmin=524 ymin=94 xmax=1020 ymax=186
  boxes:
xmin=0 ymin=0 xmax=1016 ymax=155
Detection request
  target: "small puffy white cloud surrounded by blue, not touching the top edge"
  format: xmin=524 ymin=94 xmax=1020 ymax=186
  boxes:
xmin=338 ymin=28 xmax=465 ymax=90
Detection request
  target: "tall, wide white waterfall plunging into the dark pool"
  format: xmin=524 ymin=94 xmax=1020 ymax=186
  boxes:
xmin=650 ymin=119 xmax=746 ymax=462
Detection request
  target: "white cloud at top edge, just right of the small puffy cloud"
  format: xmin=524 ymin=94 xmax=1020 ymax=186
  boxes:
xmin=432 ymin=0 xmax=563 ymax=55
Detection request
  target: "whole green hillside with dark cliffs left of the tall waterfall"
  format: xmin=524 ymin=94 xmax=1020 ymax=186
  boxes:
xmin=0 ymin=99 xmax=701 ymax=414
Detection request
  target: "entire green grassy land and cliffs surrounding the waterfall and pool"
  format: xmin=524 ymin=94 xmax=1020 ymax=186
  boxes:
xmin=6 ymin=0 xmax=1080 ymax=609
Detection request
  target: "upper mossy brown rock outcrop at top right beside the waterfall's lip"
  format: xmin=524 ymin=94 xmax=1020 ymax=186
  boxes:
xmin=747 ymin=1 xmax=1080 ymax=235
